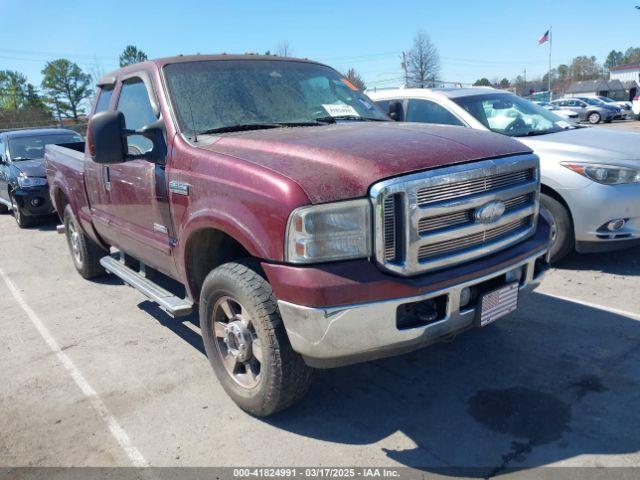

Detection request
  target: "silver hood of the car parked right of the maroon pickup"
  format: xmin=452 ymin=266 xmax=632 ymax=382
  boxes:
xmin=519 ymin=127 xmax=640 ymax=168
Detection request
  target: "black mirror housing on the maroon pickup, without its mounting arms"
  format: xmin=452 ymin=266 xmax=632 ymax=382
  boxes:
xmin=87 ymin=111 xmax=127 ymax=164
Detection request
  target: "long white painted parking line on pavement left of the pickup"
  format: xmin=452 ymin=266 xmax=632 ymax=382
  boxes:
xmin=0 ymin=269 xmax=149 ymax=467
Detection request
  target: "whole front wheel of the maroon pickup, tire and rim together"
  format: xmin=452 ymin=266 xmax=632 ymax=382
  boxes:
xmin=200 ymin=260 xmax=312 ymax=417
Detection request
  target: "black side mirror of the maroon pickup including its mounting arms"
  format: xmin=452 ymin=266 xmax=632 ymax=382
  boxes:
xmin=88 ymin=111 xmax=167 ymax=165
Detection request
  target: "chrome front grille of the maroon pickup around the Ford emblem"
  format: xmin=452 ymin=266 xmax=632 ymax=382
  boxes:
xmin=371 ymin=155 xmax=539 ymax=275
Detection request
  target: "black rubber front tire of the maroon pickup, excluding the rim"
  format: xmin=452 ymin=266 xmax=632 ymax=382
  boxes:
xmin=200 ymin=259 xmax=312 ymax=417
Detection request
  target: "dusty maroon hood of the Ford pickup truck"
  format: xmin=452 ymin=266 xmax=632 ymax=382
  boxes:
xmin=201 ymin=122 xmax=530 ymax=203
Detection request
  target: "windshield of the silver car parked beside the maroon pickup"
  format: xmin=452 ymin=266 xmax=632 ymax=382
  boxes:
xmin=453 ymin=93 xmax=571 ymax=137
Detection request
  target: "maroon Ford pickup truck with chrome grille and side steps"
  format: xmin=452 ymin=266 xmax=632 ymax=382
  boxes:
xmin=46 ymin=55 xmax=549 ymax=415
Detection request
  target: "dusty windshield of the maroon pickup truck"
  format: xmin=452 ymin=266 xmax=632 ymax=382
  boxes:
xmin=164 ymin=60 xmax=389 ymax=133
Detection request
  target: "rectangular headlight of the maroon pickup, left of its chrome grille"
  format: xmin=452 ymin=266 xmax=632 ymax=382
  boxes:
xmin=285 ymin=199 xmax=371 ymax=263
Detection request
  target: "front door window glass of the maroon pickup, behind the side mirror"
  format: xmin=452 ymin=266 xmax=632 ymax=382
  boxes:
xmin=117 ymin=78 xmax=157 ymax=154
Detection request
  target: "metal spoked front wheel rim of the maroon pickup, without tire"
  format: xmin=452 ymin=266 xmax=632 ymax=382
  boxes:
xmin=211 ymin=296 xmax=263 ymax=388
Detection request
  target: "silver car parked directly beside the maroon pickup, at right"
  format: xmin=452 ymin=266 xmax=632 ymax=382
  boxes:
xmin=367 ymin=88 xmax=640 ymax=261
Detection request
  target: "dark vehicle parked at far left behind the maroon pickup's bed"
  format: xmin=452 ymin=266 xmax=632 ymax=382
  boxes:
xmin=0 ymin=128 xmax=83 ymax=228
